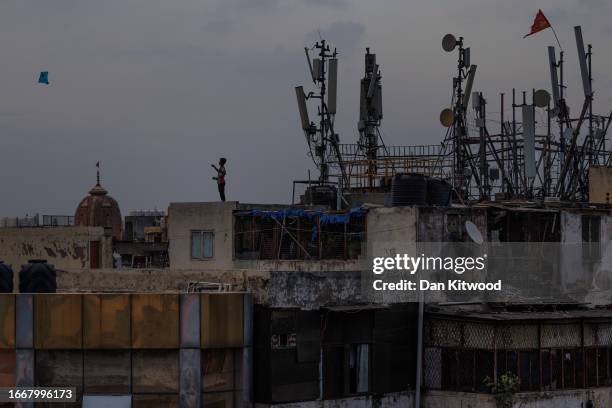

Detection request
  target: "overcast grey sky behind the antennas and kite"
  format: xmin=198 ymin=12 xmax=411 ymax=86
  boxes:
xmin=0 ymin=0 xmax=612 ymax=216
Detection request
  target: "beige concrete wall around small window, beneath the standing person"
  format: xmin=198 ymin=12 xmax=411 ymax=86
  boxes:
xmin=168 ymin=202 xmax=238 ymax=270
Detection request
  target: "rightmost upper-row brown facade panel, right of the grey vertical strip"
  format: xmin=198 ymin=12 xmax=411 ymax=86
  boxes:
xmin=201 ymin=293 xmax=244 ymax=348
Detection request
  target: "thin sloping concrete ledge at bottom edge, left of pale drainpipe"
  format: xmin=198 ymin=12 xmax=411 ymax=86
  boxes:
xmin=255 ymin=392 xmax=412 ymax=408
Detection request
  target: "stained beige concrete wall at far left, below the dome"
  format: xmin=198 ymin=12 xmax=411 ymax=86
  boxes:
xmin=0 ymin=227 xmax=112 ymax=272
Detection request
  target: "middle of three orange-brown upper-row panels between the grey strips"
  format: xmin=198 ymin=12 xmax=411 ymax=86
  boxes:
xmin=83 ymin=295 xmax=131 ymax=349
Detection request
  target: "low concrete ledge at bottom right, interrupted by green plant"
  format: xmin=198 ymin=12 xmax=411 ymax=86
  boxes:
xmin=423 ymin=387 xmax=612 ymax=408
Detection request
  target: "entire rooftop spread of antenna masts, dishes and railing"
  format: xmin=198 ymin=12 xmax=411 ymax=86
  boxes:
xmin=294 ymin=27 xmax=612 ymax=207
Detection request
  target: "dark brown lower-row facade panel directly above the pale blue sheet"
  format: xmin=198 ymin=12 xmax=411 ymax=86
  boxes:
xmin=83 ymin=350 xmax=132 ymax=394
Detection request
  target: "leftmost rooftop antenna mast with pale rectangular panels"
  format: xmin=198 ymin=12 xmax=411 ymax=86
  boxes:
xmin=295 ymin=40 xmax=347 ymax=184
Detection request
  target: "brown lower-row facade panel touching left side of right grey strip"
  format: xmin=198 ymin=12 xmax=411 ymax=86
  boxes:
xmin=132 ymin=350 xmax=179 ymax=394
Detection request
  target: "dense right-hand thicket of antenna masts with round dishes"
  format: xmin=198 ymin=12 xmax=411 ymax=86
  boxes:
xmin=440 ymin=27 xmax=612 ymax=201
